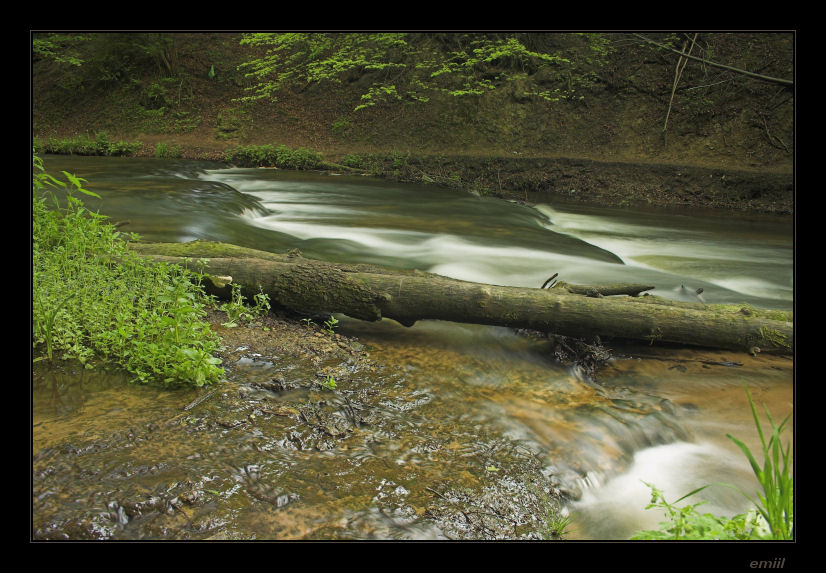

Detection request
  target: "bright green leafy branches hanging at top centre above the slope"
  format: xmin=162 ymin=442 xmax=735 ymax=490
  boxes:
xmin=235 ymin=33 xmax=611 ymax=110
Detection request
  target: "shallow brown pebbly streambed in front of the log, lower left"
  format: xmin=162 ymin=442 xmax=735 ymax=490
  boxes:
xmin=32 ymin=313 xmax=564 ymax=540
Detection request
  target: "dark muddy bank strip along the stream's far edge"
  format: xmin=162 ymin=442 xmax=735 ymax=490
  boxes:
xmin=124 ymin=139 xmax=794 ymax=215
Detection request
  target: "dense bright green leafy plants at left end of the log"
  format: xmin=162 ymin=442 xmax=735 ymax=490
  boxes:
xmin=32 ymin=157 xmax=223 ymax=386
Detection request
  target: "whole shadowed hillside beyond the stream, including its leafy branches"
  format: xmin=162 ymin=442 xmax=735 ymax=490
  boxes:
xmin=32 ymin=33 xmax=795 ymax=213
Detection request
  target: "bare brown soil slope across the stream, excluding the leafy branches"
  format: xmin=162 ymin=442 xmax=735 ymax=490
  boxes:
xmin=33 ymin=33 xmax=794 ymax=214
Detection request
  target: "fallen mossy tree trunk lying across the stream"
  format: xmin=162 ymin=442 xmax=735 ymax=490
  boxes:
xmin=132 ymin=237 xmax=793 ymax=353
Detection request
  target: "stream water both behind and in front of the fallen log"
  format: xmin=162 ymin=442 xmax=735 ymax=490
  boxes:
xmin=33 ymin=156 xmax=794 ymax=539
